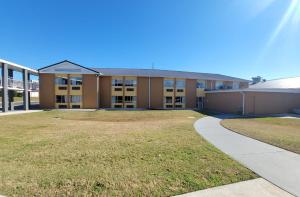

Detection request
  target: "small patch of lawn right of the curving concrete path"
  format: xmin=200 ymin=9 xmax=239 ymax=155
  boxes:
xmin=221 ymin=118 xmax=300 ymax=154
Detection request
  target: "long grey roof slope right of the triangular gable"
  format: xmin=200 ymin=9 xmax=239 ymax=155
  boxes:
xmin=92 ymin=68 xmax=249 ymax=82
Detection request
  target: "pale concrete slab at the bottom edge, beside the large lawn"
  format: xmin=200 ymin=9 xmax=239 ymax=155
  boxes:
xmin=177 ymin=178 xmax=292 ymax=197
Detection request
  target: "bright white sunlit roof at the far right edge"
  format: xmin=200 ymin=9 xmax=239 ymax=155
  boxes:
xmin=249 ymin=77 xmax=300 ymax=90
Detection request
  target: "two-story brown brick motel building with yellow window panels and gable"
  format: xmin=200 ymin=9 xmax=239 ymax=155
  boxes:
xmin=39 ymin=60 xmax=248 ymax=109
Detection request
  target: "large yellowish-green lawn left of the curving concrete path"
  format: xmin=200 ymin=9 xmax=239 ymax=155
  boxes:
xmin=0 ymin=111 xmax=256 ymax=196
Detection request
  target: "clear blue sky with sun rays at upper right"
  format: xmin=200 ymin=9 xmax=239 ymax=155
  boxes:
xmin=0 ymin=0 xmax=300 ymax=79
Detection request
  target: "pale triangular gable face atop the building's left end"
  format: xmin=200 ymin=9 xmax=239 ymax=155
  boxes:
xmin=39 ymin=62 xmax=98 ymax=74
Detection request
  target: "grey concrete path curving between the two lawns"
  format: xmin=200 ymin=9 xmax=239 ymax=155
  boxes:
xmin=194 ymin=116 xmax=300 ymax=196
